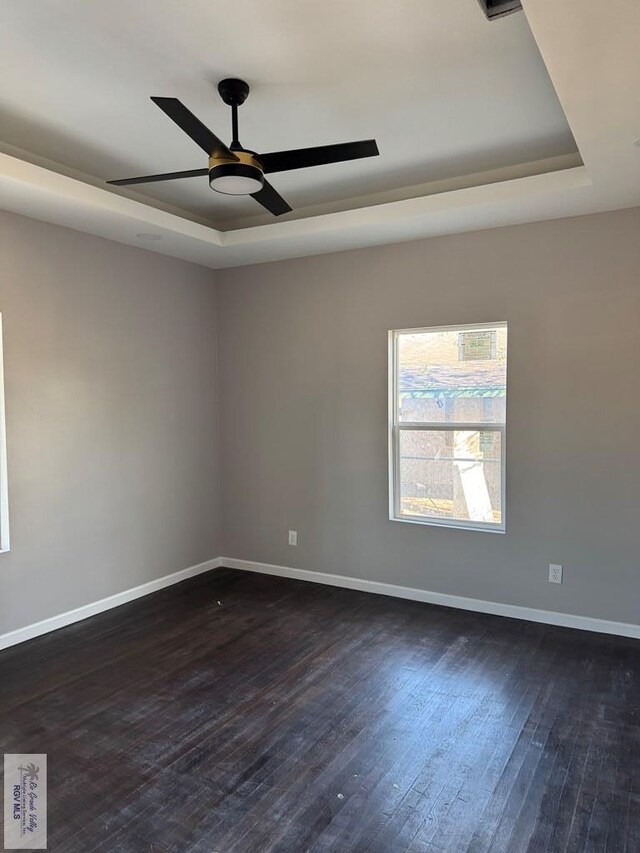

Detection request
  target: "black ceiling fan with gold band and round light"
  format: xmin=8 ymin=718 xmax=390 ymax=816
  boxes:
xmin=107 ymin=78 xmax=380 ymax=216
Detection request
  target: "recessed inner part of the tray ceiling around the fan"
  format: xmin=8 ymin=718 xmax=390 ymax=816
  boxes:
xmin=0 ymin=0 xmax=576 ymax=227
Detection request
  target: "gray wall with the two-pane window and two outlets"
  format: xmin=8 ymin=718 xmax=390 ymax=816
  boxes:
xmin=218 ymin=210 xmax=640 ymax=622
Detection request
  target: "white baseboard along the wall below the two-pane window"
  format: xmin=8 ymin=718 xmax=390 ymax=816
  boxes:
xmin=218 ymin=557 xmax=640 ymax=639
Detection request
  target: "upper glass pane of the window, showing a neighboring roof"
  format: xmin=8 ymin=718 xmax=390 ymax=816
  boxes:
xmin=397 ymin=326 xmax=507 ymax=424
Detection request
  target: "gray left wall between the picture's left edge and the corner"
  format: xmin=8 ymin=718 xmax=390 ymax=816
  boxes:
xmin=0 ymin=214 xmax=220 ymax=634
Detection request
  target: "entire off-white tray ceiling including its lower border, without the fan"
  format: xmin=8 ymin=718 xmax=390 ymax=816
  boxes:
xmin=0 ymin=0 xmax=640 ymax=268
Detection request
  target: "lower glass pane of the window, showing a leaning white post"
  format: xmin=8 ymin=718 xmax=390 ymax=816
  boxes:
xmin=399 ymin=429 xmax=502 ymax=524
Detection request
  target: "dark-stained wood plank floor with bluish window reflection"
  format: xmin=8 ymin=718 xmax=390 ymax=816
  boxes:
xmin=0 ymin=569 xmax=640 ymax=853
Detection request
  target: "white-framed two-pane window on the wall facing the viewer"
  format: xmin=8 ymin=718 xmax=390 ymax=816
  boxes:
xmin=389 ymin=323 xmax=507 ymax=532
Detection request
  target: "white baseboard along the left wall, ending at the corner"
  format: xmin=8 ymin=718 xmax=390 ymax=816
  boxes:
xmin=0 ymin=557 xmax=222 ymax=649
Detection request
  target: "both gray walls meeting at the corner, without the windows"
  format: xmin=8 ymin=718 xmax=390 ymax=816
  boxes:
xmin=0 ymin=205 xmax=640 ymax=634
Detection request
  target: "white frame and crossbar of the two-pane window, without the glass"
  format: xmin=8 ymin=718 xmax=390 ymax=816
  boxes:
xmin=388 ymin=321 xmax=509 ymax=533
